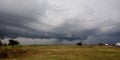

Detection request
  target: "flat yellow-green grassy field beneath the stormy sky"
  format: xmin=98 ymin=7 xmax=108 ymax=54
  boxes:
xmin=0 ymin=45 xmax=120 ymax=60
